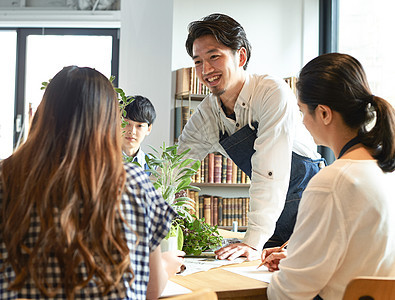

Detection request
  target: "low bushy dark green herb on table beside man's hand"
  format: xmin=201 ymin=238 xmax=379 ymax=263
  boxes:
xmin=180 ymin=215 xmax=223 ymax=255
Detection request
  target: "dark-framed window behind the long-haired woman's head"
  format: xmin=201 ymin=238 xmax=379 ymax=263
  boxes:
xmin=0 ymin=28 xmax=119 ymax=158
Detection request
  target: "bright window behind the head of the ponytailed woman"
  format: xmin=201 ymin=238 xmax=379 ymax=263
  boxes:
xmin=338 ymin=0 xmax=395 ymax=106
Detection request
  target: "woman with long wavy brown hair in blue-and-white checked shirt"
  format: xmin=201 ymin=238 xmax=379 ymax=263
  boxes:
xmin=0 ymin=66 xmax=182 ymax=299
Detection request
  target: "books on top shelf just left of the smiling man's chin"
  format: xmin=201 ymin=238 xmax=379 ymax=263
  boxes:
xmin=176 ymin=67 xmax=210 ymax=95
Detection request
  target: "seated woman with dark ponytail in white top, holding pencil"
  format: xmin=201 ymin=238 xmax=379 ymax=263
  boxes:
xmin=262 ymin=53 xmax=395 ymax=299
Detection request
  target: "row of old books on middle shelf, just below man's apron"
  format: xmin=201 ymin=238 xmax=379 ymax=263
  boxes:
xmin=192 ymin=153 xmax=251 ymax=183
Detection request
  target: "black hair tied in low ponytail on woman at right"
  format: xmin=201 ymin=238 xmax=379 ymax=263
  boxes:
xmin=296 ymin=53 xmax=395 ymax=172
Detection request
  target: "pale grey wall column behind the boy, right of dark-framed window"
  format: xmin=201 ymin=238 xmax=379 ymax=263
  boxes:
xmin=119 ymin=0 xmax=173 ymax=151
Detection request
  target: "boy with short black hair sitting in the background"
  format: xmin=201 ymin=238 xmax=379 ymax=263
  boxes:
xmin=122 ymin=95 xmax=156 ymax=170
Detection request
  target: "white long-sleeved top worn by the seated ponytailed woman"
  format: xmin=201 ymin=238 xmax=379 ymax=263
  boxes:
xmin=267 ymin=159 xmax=395 ymax=300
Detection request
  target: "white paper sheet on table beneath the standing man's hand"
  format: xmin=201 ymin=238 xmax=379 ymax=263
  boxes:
xmin=177 ymin=257 xmax=248 ymax=276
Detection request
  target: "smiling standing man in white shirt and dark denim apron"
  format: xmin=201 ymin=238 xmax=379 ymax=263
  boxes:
xmin=179 ymin=14 xmax=323 ymax=260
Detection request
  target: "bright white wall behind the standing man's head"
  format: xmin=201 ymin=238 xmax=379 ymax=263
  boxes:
xmin=172 ymin=0 xmax=318 ymax=77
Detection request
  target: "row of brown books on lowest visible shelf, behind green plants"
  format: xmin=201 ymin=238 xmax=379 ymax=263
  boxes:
xmin=188 ymin=190 xmax=250 ymax=226
